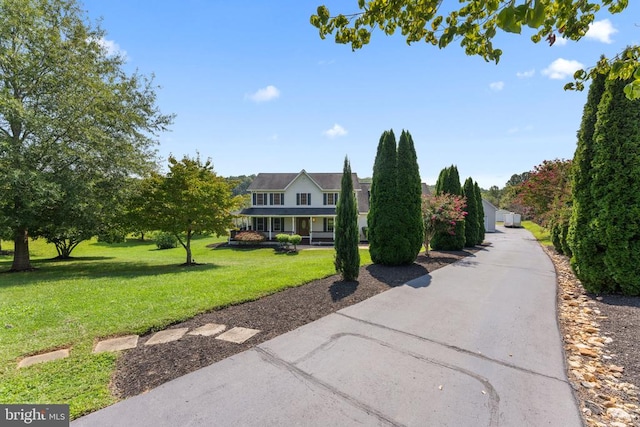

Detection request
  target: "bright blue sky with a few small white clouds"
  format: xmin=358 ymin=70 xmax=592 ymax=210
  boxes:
xmin=82 ymin=0 xmax=640 ymax=189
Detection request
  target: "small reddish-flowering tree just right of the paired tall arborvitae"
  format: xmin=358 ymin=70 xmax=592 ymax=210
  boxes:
xmin=422 ymin=193 xmax=467 ymax=256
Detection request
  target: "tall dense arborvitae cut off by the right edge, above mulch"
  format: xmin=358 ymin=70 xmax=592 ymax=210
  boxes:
xmin=591 ymin=70 xmax=640 ymax=295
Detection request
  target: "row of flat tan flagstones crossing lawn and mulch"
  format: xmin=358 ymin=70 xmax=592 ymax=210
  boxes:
xmin=18 ymin=323 xmax=260 ymax=368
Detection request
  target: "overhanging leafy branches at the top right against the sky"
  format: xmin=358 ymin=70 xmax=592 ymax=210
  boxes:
xmin=310 ymin=0 xmax=640 ymax=99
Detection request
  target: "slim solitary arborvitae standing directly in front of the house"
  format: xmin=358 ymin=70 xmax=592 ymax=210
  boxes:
xmin=335 ymin=157 xmax=360 ymax=281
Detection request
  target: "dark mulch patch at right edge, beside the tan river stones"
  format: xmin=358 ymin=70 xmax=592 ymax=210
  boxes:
xmin=594 ymin=295 xmax=640 ymax=388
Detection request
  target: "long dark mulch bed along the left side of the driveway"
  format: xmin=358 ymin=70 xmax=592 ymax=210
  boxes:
xmin=112 ymin=247 xmax=480 ymax=398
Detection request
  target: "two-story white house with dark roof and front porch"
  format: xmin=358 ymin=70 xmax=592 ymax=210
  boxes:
xmin=240 ymin=169 xmax=370 ymax=244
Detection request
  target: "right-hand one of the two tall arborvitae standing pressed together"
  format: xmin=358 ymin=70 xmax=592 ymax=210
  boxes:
xmin=396 ymin=130 xmax=424 ymax=264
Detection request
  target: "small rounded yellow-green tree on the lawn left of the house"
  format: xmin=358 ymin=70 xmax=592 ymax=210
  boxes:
xmin=141 ymin=156 xmax=242 ymax=266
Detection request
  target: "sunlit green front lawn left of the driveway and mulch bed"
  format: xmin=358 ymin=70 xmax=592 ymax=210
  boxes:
xmin=0 ymin=238 xmax=371 ymax=417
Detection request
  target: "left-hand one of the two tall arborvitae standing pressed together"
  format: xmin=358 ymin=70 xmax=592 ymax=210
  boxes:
xmin=367 ymin=130 xmax=400 ymax=265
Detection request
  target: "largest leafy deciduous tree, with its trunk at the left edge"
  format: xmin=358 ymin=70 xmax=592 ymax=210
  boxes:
xmin=0 ymin=0 xmax=172 ymax=271
